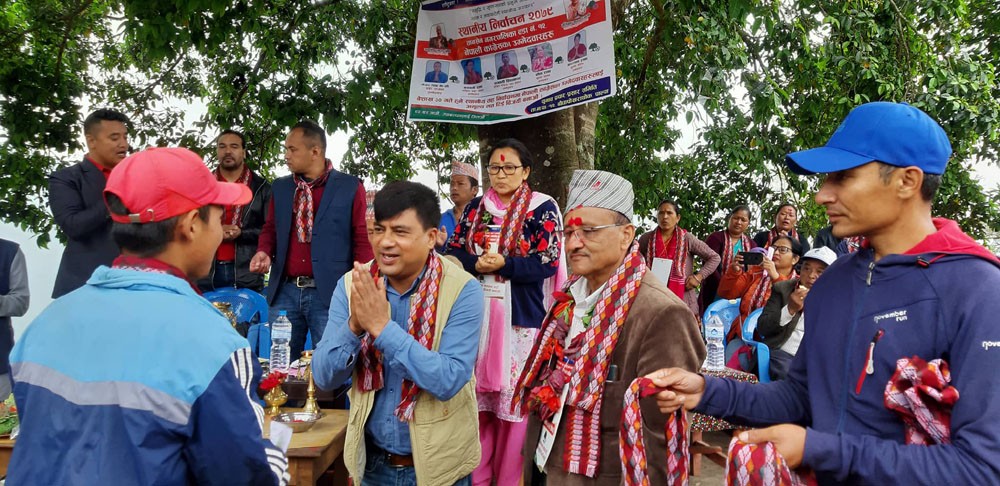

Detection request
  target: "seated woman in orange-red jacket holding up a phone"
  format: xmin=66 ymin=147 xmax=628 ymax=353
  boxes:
xmin=719 ymin=236 xmax=802 ymax=342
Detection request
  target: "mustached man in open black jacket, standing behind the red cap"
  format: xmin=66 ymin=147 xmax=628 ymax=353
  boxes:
xmin=198 ymin=130 xmax=271 ymax=292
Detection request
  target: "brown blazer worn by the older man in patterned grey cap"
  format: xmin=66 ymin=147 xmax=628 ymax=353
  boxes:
xmin=523 ymin=273 xmax=705 ymax=486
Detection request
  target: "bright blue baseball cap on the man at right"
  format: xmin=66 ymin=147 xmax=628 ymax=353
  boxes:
xmin=785 ymin=101 xmax=951 ymax=175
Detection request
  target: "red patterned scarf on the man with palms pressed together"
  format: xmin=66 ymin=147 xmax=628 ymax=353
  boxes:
xmin=357 ymin=252 xmax=442 ymax=422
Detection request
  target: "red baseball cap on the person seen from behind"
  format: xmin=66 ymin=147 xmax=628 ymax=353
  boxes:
xmin=104 ymin=147 xmax=253 ymax=223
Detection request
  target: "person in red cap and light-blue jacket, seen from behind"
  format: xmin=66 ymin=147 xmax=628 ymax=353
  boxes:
xmin=7 ymin=148 xmax=288 ymax=485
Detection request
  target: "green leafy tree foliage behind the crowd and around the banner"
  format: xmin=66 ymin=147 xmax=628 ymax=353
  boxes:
xmin=0 ymin=0 xmax=1000 ymax=245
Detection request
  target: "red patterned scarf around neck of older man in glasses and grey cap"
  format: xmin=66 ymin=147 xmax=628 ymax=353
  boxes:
xmin=512 ymin=243 xmax=646 ymax=478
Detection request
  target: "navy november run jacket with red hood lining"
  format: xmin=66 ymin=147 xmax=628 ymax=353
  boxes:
xmin=696 ymin=219 xmax=1000 ymax=485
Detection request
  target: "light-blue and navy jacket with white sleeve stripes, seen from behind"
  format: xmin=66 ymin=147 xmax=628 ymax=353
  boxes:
xmin=7 ymin=266 xmax=288 ymax=485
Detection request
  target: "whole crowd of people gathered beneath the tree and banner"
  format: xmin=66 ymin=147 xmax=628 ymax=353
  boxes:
xmin=0 ymin=102 xmax=1000 ymax=485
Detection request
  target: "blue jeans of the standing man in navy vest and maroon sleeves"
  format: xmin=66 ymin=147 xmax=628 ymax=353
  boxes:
xmin=268 ymin=283 xmax=330 ymax=361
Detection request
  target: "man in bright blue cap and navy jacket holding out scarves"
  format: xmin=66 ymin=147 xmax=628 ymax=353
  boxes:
xmin=650 ymin=102 xmax=1000 ymax=484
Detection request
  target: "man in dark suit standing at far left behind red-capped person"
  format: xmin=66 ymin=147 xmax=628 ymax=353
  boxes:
xmin=49 ymin=109 xmax=129 ymax=299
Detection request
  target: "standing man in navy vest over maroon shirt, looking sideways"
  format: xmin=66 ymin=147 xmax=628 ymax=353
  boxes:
xmin=250 ymin=121 xmax=372 ymax=359
